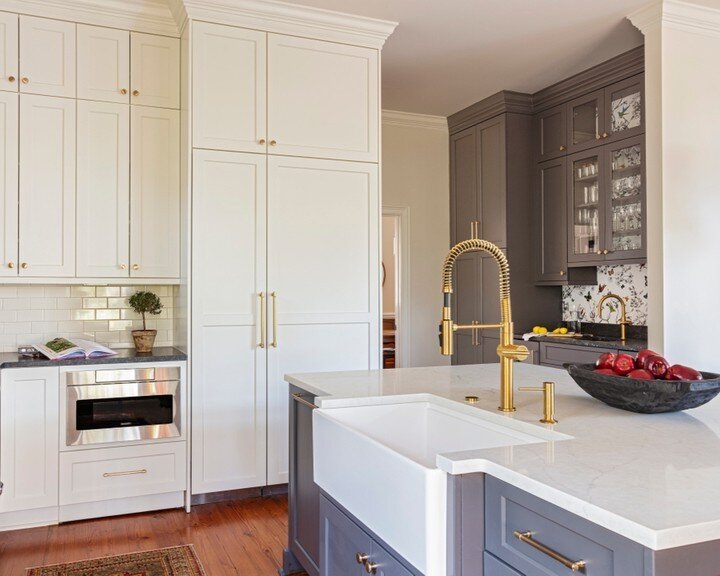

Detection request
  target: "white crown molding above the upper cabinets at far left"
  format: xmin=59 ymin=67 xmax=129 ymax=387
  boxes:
xmin=0 ymin=0 xmax=178 ymax=37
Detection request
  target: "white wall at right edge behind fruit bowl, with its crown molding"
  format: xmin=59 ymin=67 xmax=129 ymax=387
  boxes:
xmin=630 ymin=0 xmax=720 ymax=372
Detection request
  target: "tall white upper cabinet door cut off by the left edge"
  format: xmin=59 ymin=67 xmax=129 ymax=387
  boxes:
xmin=0 ymin=92 xmax=19 ymax=276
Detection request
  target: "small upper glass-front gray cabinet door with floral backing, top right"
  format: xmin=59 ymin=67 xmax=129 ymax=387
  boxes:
xmin=601 ymin=74 xmax=645 ymax=142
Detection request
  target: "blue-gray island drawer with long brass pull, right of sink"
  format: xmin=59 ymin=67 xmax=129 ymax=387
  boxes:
xmin=485 ymin=477 xmax=643 ymax=576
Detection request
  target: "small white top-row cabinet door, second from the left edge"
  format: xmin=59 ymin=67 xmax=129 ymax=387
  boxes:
xmin=20 ymin=16 xmax=75 ymax=98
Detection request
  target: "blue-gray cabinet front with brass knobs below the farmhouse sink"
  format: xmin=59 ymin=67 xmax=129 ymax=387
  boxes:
xmin=320 ymin=494 xmax=420 ymax=576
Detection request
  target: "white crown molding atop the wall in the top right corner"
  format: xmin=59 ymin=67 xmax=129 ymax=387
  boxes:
xmin=627 ymin=0 xmax=720 ymax=38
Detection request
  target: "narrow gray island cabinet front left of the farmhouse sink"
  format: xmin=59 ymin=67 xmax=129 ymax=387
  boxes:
xmin=282 ymin=386 xmax=320 ymax=576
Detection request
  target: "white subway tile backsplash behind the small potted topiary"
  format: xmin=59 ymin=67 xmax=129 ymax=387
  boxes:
xmin=0 ymin=285 xmax=175 ymax=352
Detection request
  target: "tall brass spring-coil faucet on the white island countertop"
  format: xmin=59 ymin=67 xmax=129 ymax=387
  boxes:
xmin=440 ymin=238 xmax=530 ymax=412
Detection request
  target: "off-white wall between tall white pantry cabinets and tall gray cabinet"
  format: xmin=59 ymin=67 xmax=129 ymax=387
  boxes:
xmin=382 ymin=111 xmax=450 ymax=367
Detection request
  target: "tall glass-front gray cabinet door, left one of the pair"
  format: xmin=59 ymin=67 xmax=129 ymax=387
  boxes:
xmin=568 ymin=149 xmax=605 ymax=262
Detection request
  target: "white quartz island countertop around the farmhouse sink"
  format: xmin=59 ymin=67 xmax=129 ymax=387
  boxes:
xmin=286 ymin=364 xmax=720 ymax=550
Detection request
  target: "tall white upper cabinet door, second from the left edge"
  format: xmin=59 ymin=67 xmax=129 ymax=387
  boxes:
xmin=19 ymin=94 xmax=75 ymax=277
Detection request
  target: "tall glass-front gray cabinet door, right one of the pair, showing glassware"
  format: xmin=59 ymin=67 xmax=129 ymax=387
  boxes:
xmin=601 ymin=137 xmax=646 ymax=260
